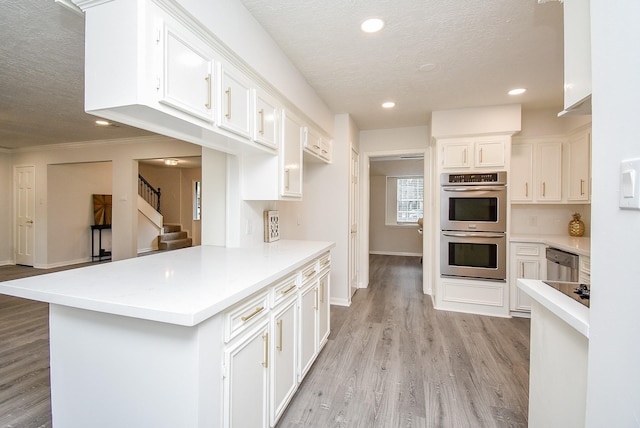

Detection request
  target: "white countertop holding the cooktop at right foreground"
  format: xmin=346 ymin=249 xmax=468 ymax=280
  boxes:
xmin=518 ymin=279 xmax=589 ymax=338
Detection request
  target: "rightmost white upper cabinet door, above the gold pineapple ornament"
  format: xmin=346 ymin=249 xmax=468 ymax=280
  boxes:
xmin=567 ymin=132 xmax=591 ymax=201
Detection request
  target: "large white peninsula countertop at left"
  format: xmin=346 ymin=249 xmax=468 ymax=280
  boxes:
xmin=0 ymin=240 xmax=335 ymax=326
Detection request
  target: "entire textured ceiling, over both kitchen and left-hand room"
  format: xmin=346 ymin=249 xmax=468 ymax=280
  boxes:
xmin=0 ymin=0 xmax=563 ymax=148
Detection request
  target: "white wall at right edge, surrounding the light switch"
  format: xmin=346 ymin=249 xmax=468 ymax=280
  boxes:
xmin=586 ymin=0 xmax=640 ymax=428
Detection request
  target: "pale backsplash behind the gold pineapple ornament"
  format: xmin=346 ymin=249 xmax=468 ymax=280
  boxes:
xmin=511 ymin=204 xmax=591 ymax=236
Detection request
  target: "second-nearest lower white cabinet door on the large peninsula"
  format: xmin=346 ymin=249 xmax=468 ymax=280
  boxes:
xmin=271 ymin=299 xmax=298 ymax=426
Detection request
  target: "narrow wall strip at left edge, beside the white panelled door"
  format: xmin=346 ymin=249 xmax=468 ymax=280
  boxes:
xmin=0 ymin=149 xmax=13 ymax=266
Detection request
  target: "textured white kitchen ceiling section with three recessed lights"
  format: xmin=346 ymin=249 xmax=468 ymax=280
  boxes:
xmin=241 ymin=0 xmax=563 ymax=130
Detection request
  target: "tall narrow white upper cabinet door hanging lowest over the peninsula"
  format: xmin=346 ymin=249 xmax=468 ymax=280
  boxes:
xmin=280 ymin=111 xmax=304 ymax=198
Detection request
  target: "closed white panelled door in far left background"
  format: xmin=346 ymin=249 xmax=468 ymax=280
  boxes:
xmin=14 ymin=166 xmax=36 ymax=266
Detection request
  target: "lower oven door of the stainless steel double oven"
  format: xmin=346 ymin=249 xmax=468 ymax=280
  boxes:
xmin=440 ymin=231 xmax=507 ymax=281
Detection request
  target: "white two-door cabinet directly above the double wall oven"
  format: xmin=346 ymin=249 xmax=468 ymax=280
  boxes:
xmin=439 ymin=136 xmax=510 ymax=170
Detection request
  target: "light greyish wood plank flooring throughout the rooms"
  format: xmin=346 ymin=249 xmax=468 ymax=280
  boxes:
xmin=0 ymin=255 xmax=529 ymax=428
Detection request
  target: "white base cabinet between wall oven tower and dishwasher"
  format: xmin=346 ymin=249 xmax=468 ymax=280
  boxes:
xmin=509 ymin=242 xmax=547 ymax=312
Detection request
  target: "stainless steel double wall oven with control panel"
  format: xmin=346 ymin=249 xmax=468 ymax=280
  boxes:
xmin=440 ymin=171 xmax=507 ymax=281
